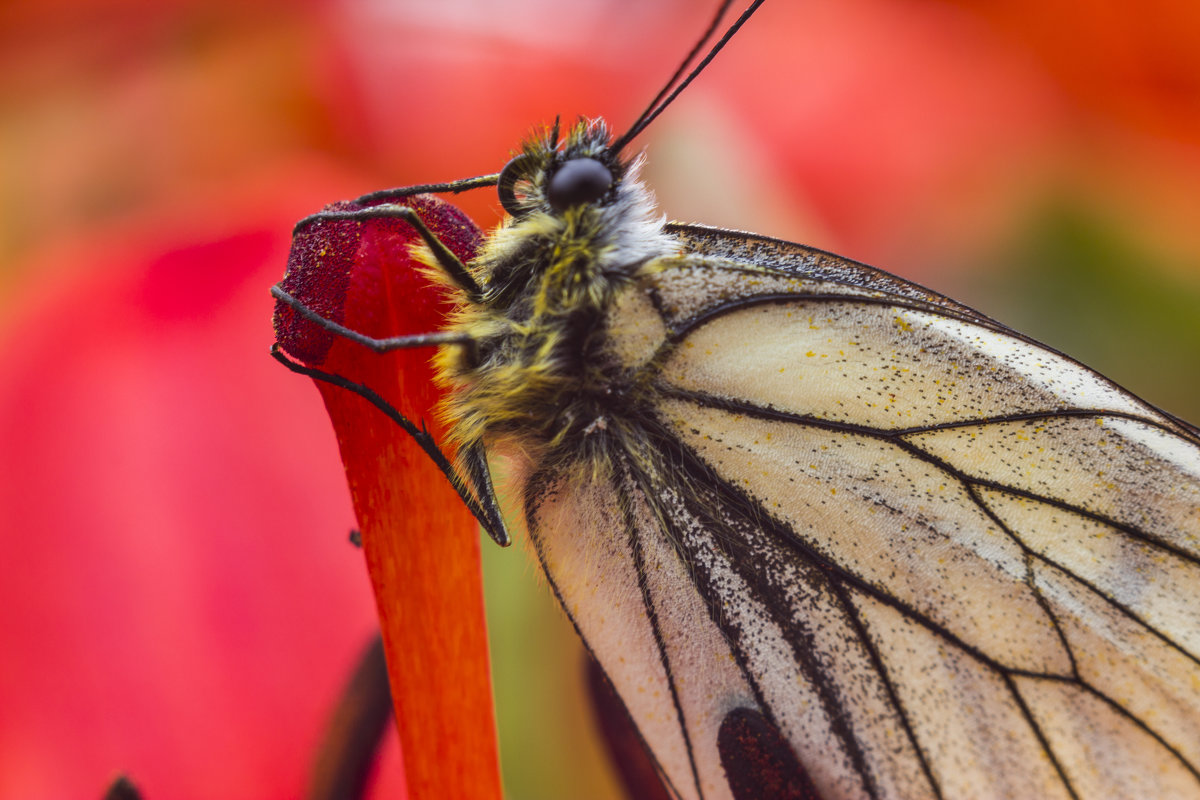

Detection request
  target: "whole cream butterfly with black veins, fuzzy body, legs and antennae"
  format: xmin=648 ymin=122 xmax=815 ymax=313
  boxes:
xmin=275 ymin=0 xmax=1200 ymax=800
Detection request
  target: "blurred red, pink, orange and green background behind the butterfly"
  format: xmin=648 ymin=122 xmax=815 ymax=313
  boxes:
xmin=0 ymin=0 xmax=1200 ymax=800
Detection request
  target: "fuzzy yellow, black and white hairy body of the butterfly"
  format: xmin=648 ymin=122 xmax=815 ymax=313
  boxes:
xmin=439 ymin=124 xmax=678 ymax=474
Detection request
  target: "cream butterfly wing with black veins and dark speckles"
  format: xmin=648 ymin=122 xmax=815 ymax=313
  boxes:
xmin=521 ymin=225 xmax=1200 ymax=800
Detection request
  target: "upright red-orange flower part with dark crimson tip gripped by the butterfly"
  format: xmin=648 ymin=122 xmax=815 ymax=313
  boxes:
xmin=275 ymin=190 xmax=500 ymax=799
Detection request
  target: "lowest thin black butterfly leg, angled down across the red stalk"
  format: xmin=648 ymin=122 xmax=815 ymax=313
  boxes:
xmin=271 ymin=344 xmax=512 ymax=547
